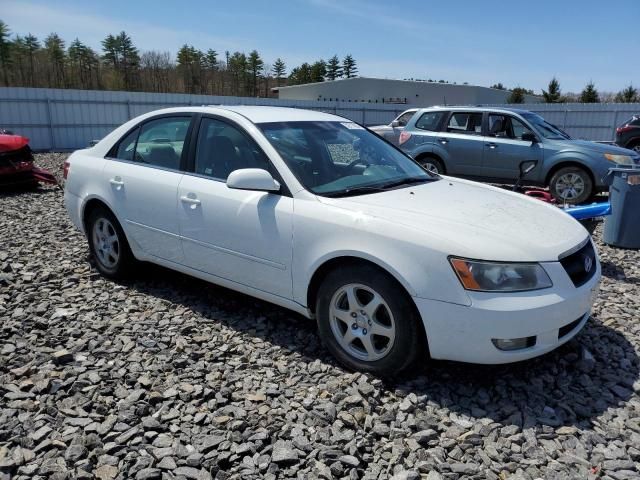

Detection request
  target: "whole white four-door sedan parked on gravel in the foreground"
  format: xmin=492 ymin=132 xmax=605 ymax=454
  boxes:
xmin=65 ymin=106 xmax=600 ymax=375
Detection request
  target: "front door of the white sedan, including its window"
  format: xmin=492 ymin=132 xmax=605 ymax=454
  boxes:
xmin=178 ymin=117 xmax=293 ymax=298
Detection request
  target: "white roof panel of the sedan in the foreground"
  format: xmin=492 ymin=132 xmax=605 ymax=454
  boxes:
xmin=143 ymin=105 xmax=350 ymax=123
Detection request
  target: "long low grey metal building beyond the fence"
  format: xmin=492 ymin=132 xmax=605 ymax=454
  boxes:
xmin=273 ymin=77 xmax=541 ymax=106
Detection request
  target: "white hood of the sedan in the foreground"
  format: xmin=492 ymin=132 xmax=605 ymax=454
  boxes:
xmin=319 ymin=177 xmax=588 ymax=262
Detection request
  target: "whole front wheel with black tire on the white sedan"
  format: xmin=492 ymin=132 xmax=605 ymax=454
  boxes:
xmin=316 ymin=265 xmax=427 ymax=377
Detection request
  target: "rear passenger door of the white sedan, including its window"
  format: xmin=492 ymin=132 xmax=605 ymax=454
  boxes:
xmin=102 ymin=115 xmax=192 ymax=263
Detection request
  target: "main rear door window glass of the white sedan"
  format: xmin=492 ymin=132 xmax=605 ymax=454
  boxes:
xmin=134 ymin=117 xmax=191 ymax=170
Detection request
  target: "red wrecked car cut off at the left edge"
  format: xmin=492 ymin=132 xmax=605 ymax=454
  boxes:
xmin=0 ymin=130 xmax=58 ymax=187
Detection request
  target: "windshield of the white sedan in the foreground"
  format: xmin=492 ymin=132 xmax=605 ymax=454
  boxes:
xmin=258 ymin=121 xmax=439 ymax=197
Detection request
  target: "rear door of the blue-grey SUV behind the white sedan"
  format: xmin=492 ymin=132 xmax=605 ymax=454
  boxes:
xmin=434 ymin=111 xmax=485 ymax=176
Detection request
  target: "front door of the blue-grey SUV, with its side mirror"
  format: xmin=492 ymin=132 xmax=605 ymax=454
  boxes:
xmin=483 ymin=113 xmax=543 ymax=182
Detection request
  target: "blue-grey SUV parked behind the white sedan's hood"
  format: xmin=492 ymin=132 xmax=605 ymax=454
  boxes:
xmin=398 ymin=107 xmax=640 ymax=203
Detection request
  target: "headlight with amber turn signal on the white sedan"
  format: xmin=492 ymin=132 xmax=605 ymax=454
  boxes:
xmin=449 ymin=257 xmax=553 ymax=292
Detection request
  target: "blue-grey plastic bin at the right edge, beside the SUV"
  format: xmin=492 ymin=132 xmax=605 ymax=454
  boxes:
xmin=604 ymin=166 xmax=640 ymax=248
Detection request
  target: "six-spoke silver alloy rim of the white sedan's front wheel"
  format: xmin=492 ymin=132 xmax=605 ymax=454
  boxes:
xmin=329 ymin=283 xmax=396 ymax=362
